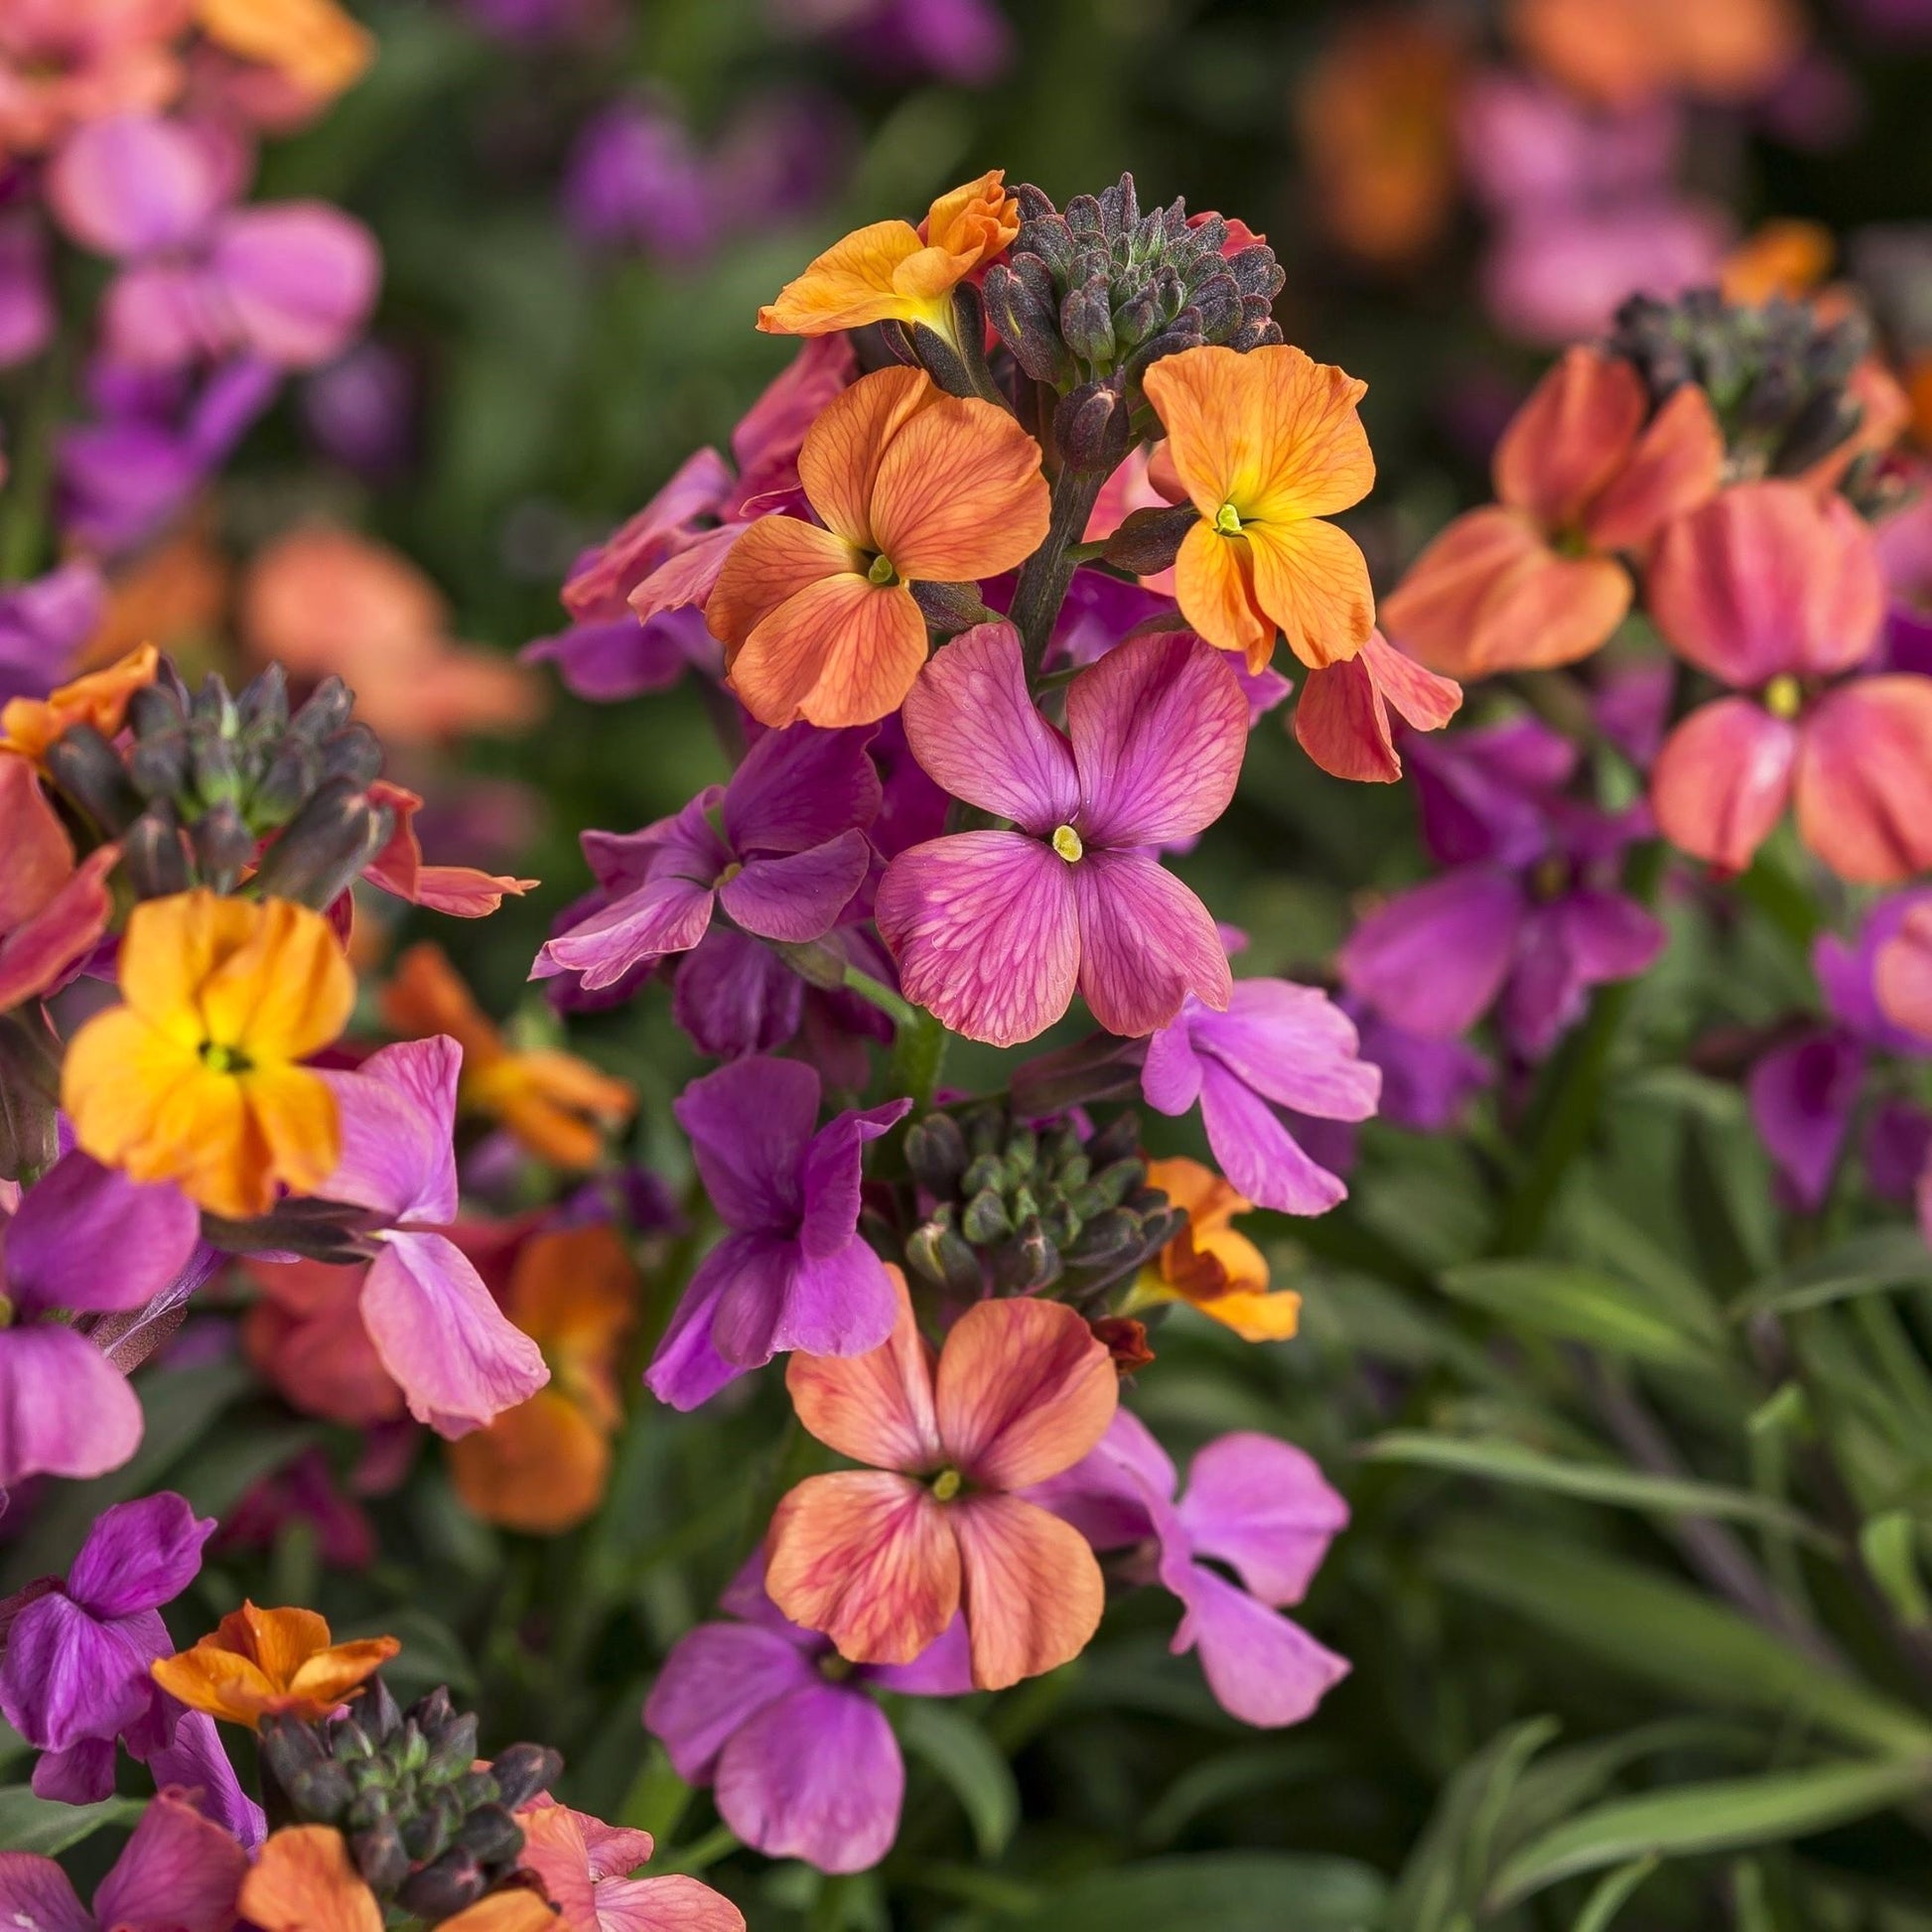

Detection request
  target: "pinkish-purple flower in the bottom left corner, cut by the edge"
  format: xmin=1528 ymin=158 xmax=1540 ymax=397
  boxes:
xmin=0 ymin=1791 xmax=249 ymax=1932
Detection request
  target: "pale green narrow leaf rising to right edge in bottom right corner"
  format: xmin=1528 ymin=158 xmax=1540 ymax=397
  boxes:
xmin=1489 ymin=1758 xmax=1932 ymax=1911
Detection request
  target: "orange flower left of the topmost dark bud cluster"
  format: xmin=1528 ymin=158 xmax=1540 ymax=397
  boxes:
xmin=758 ymin=168 xmax=1020 ymax=342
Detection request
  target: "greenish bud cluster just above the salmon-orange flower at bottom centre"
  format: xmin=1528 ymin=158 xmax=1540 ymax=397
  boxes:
xmin=906 ymin=1101 xmax=1180 ymax=1299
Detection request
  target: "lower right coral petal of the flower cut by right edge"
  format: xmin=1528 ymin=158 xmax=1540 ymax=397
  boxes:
xmin=1797 ymin=676 xmax=1932 ymax=885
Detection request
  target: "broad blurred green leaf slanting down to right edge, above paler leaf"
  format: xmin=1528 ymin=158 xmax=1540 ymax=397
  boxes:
xmin=1430 ymin=1519 xmax=1932 ymax=1752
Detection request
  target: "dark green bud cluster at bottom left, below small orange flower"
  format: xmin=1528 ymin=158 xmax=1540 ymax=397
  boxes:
xmin=261 ymin=1679 xmax=562 ymax=1924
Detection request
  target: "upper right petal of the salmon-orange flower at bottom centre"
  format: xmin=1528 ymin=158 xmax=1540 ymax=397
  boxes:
xmin=937 ymin=1299 xmax=1119 ymax=1489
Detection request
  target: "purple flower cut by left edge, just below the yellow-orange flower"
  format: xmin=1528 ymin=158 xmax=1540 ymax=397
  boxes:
xmin=0 ymin=1154 xmax=201 ymax=1489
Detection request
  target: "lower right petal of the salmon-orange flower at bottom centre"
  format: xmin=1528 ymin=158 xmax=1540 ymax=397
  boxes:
xmin=950 ymin=1483 xmax=1113 ymax=1691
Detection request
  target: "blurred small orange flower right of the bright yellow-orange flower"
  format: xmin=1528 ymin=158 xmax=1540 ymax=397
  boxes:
xmin=380 ymin=941 xmax=637 ymax=1167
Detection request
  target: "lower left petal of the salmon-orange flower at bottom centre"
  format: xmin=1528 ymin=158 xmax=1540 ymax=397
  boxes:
xmin=765 ymin=1470 xmax=958 ymax=1664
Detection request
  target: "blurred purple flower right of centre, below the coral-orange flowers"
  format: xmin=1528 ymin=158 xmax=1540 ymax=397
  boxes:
xmin=1337 ymin=719 xmax=1664 ymax=1058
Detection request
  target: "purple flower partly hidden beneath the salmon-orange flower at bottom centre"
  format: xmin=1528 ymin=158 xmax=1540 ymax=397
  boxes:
xmin=643 ymin=1557 xmax=972 ymax=1872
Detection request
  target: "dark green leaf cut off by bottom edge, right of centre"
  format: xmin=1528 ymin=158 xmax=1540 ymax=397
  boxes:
xmin=1020 ymin=1853 xmax=1387 ymax=1932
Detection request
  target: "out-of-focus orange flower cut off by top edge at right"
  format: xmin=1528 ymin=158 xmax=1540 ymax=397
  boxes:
xmin=1509 ymin=0 xmax=1805 ymax=106
